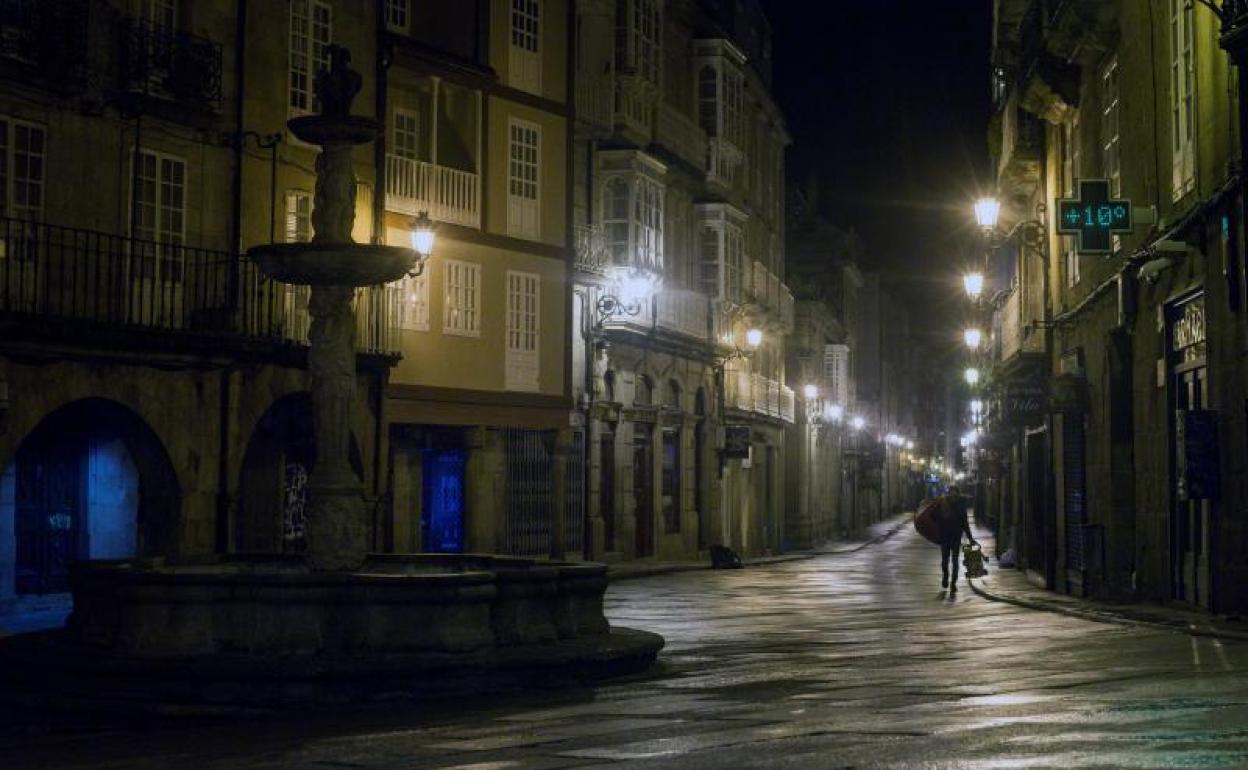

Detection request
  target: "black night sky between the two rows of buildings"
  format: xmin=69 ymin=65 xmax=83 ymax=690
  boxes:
xmin=764 ymin=0 xmax=992 ymax=336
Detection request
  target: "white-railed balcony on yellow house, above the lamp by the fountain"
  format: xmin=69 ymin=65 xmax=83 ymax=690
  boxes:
xmin=386 ymin=155 xmax=480 ymax=228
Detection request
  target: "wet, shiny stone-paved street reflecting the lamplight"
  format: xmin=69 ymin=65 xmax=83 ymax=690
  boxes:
xmin=12 ymin=519 xmax=1248 ymax=770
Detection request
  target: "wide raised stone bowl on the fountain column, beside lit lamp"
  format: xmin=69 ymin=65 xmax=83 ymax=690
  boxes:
xmin=247 ymin=243 xmax=417 ymax=287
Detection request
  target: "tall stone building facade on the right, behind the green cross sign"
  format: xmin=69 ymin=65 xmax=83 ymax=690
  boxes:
xmin=985 ymin=0 xmax=1248 ymax=612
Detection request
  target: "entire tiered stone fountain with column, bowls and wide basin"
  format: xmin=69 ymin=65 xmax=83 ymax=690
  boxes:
xmin=0 ymin=46 xmax=663 ymax=711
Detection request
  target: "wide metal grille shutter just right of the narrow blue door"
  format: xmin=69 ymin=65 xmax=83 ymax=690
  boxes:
xmin=503 ymin=428 xmax=554 ymax=557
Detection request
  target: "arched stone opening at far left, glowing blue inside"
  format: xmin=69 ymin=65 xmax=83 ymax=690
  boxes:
xmin=0 ymin=398 xmax=182 ymax=599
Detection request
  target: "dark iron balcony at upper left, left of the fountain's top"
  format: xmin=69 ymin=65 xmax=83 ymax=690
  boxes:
xmin=119 ymin=19 xmax=221 ymax=112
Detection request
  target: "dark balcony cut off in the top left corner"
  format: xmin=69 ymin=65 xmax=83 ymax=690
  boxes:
xmin=0 ymin=0 xmax=89 ymax=92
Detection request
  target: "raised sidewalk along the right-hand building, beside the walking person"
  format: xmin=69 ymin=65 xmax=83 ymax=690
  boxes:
xmin=968 ymin=541 xmax=1248 ymax=641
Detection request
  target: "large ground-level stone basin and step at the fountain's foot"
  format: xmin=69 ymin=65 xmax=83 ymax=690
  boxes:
xmin=0 ymin=554 xmax=663 ymax=714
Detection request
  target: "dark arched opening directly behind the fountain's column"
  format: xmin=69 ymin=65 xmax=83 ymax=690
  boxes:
xmin=231 ymin=391 xmax=364 ymax=553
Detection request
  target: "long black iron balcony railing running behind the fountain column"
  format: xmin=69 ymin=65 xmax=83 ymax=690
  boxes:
xmin=0 ymin=217 xmax=398 ymax=356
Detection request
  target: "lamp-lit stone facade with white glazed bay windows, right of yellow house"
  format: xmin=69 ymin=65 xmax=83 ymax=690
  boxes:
xmin=572 ymin=0 xmax=794 ymax=559
